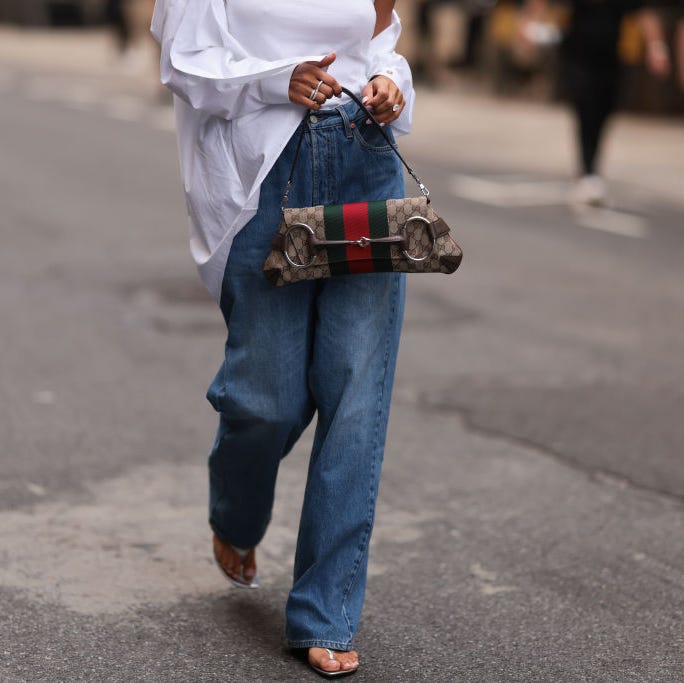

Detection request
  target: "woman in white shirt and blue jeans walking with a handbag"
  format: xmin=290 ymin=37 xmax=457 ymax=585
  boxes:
xmin=152 ymin=0 xmax=413 ymax=675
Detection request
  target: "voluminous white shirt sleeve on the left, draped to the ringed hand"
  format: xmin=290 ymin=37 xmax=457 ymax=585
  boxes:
xmin=152 ymin=0 xmax=325 ymax=119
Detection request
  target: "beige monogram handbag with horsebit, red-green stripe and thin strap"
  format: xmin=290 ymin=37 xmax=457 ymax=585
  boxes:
xmin=263 ymin=88 xmax=463 ymax=286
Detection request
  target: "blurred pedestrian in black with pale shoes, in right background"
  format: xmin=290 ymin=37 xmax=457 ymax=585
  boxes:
xmin=523 ymin=0 xmax=656 ymax=205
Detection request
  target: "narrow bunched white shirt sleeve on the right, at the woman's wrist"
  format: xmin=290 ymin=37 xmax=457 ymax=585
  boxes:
xmin=368 ymin=11 xmax=416 ymax=135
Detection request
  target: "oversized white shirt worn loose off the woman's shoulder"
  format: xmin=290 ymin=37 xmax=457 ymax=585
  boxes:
xmin=152 ymin=0 xmax=414 ymax=301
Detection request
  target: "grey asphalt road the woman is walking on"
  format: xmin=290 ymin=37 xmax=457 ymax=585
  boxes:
xmin=0 ymin=81 xmax=684 ymax=683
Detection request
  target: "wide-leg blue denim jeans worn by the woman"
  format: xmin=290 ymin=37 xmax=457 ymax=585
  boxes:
xmin=207 ymin=103 xmax=405 ymax=650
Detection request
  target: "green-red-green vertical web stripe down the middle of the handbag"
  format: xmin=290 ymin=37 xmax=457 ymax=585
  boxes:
xmin=323 ymin=202 xmax=392 ymax=275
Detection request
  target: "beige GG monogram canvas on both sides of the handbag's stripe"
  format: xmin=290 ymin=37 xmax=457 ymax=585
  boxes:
xmin=264 ymin=197 xmax=462 ymax=286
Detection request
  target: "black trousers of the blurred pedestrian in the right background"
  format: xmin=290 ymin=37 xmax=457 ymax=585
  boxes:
xmin=564 ymin=60 xmax=619 ymax=175
